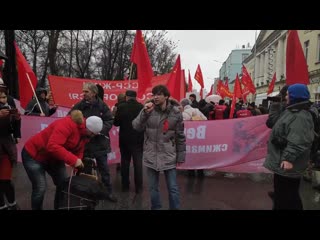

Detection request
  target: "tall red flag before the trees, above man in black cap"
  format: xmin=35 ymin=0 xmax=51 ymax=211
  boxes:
xmin=130 ymin=30 xmax=153 ymax=98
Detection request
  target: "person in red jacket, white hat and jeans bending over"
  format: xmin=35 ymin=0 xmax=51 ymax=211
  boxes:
xmin=21 ymin=110 xmax=102 ymax=210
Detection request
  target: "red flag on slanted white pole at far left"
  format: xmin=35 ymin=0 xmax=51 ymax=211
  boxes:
xmin=14 ymin=42 xmax=38 ymax=108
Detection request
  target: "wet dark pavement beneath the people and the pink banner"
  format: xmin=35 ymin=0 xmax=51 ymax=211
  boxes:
xmin=15 ymin=164 xmax=320 ymax=210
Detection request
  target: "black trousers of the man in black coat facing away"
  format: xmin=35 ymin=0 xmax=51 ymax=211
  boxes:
xmin=120 ymin=144 xmax=142 ymax=191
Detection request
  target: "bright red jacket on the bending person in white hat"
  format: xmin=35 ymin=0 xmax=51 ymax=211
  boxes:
xmin=24 ymin=111 xmax=88 ymax=166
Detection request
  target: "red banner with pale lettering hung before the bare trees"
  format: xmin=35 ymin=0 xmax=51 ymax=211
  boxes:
xmin=48 ymin=73 xmax=170 ymax=108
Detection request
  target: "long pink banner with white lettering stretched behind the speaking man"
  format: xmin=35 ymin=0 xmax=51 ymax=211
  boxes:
xmin=18 ymin=114 xmax=270 ymax=173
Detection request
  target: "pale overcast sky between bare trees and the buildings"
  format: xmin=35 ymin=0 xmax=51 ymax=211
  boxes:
xmin=167 ymin=30 xmax=260 ymax=91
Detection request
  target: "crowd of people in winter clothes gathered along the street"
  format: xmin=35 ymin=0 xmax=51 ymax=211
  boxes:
xmin=0 ymin=62 xmax=314 ymax=210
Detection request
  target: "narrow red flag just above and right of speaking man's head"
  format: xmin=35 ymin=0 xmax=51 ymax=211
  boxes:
xmin=167 ymin=54 xmax=181 ymax=101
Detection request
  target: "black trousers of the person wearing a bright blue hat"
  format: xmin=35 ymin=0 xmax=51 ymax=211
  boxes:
xmin=273 ymin=174 xmax=303 ymax=210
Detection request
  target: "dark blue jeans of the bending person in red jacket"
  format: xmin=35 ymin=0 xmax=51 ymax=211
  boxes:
xmin=21 ymin=148 xmax=68 ymax=210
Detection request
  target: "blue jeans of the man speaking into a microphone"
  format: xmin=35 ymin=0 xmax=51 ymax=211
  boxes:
xmin=147 ymin=167 xmax=180 ymax=210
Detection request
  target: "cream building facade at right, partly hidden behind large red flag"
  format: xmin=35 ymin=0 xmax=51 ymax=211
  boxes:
xmin=243 ymin=30 xmax=320 ymax=105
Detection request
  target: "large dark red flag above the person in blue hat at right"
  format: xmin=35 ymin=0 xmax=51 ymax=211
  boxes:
xmin=286 ymin=30 xmax=310 ymax=85
